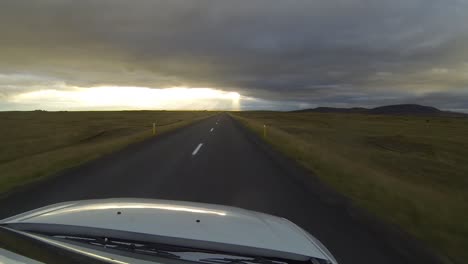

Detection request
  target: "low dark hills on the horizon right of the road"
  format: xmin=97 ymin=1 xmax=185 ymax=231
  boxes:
xmin=293 ymin=104 xmax=468 ymax=117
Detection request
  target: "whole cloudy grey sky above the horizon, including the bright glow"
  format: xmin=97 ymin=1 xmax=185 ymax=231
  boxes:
xmin=0 ymin=0 xmax=468 ymax=112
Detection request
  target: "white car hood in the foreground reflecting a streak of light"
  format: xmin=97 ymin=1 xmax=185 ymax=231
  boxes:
xmin=0 ymin=199 xmax=333 ymax=260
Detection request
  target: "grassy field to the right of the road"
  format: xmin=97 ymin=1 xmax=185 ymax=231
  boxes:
xmin=233 ymin=112 xmax=468 ymax=263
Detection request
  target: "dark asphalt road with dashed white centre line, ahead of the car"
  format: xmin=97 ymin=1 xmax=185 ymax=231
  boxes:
xmin=0 ymin=114 xmax=436 ymax=264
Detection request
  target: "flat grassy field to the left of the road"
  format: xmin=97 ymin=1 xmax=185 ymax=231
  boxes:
xmin=0 ymin=111 xmax=213 ymax=194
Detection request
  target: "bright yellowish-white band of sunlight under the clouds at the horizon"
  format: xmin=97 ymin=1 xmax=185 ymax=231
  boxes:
xmin=10 ymin=86 xmax=242 ymax=110
